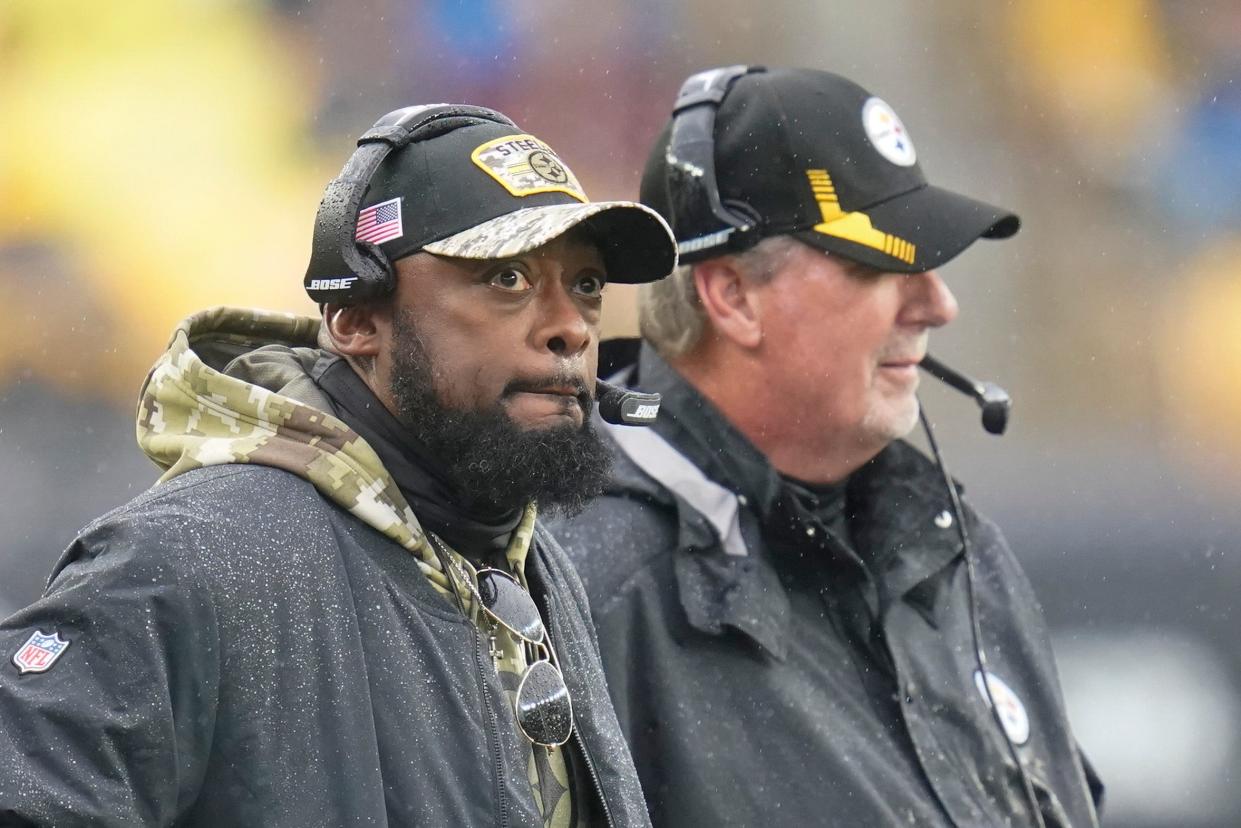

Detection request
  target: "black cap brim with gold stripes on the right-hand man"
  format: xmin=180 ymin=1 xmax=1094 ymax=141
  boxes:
xmin=793 ymin=185 xmax=1021 ymax=273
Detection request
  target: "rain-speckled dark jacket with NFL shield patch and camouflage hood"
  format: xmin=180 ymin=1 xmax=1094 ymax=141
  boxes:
xmin=0 ymin=309 xmax=648 ymax=828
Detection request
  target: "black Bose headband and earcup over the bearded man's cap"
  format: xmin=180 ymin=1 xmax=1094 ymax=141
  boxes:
xmin=303 ymin=103 xmax=516 ymax=304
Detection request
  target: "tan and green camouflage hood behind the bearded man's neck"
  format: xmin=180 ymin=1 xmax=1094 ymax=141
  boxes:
xmin=138 ymin=308 xmax=447 ymax=588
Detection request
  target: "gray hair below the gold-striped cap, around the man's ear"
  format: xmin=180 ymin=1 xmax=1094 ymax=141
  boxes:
xmin=638 ymin=236 xmax=802 ymax=359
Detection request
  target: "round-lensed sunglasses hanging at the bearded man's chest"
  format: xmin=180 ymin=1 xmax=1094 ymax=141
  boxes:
xmin=427 ymin=533 xmax=573 ymax=747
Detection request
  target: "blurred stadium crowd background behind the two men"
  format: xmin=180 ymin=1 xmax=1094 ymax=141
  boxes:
xmin=0 ymin=0 xmax=1241 ymax=826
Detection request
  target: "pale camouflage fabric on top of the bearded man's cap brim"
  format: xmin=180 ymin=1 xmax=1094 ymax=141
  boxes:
xmin=422 ymin=201 xmax=664 ymax=258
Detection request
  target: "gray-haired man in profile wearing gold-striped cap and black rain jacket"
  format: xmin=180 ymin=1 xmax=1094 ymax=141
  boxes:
xmin=557 ymin=67 xmax=1098 ymax=828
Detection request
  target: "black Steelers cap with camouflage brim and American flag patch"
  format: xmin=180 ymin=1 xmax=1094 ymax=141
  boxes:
xmin=356 ymin=122 xmax=676 ymax=283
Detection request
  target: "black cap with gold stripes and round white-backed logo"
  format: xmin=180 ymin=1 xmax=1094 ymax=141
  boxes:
xmin=640 ymin=67 xmax=1020 ymax=273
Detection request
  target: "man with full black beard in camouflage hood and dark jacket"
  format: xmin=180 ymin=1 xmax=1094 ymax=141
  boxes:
xmin=0 ymin=106 xmax=675 ymax=828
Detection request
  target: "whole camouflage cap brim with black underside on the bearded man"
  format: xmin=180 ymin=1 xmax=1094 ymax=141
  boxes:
xmin=422 ymin=201 xmax=676 ymax=283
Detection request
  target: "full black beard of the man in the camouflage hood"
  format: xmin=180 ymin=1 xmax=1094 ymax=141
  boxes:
xmin=391 ymin=313 xmax=612 ymax=515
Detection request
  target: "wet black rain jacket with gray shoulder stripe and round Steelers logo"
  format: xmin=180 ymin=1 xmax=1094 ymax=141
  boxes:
xmin=553 ymin=350 xmax=1101 ymax=828
